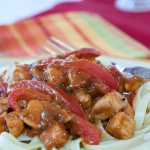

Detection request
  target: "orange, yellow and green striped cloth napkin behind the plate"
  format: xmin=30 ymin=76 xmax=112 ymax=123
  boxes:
xmin=0 ymin=12 xmax=150 ymax=58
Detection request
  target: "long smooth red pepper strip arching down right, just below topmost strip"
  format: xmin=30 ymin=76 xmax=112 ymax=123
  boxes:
xmin=52 ymin=59 xmax=119 ymax=89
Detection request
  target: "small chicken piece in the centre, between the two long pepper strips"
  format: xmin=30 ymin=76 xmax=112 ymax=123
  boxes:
xmin=73 ymin=89 xmax=91 ymax=107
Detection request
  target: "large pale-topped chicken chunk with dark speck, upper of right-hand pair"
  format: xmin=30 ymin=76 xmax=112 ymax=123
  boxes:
xmin=91 ymin=91 xmax=128 ymax=120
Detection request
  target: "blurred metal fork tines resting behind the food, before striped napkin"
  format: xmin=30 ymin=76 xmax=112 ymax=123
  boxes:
xmin=42 ymin=36 xmax=76 ymax=56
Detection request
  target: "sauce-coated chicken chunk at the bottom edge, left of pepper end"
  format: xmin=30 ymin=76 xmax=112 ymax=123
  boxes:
xmin=40 ymin=124 xmax=69 ymax=150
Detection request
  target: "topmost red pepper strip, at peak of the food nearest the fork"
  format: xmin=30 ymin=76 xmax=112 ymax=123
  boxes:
xmin=62 ymin=48 xmax=101 ymax=59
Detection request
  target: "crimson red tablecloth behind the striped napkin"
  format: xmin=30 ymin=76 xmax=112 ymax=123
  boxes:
xmin=34 ymin=0 xmax=150 ymax=48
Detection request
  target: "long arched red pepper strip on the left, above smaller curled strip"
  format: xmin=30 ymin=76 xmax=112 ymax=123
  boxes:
xmin=8 ymin=80 xmax=85 ymax=118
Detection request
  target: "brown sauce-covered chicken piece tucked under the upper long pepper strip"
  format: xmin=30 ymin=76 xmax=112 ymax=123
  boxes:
xmin=68 ymin=69 xmax=92 ymax=90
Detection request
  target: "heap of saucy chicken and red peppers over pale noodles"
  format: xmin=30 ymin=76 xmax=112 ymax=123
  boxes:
xmin=0 ymin=48 xmax=150 ymax=150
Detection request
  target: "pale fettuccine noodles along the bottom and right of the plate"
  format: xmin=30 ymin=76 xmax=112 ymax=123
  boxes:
xmin=0 ymin=53 xmax=150 ymax=150
